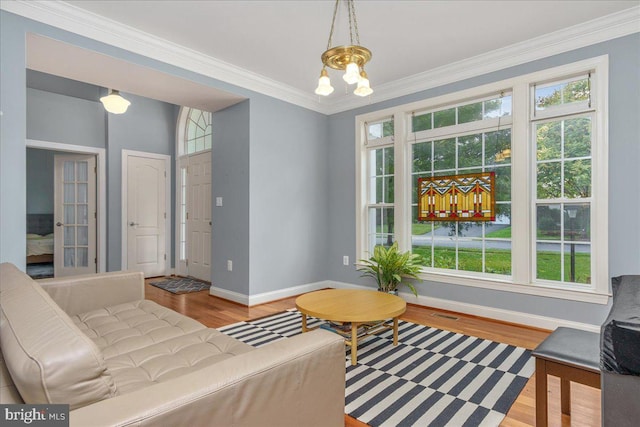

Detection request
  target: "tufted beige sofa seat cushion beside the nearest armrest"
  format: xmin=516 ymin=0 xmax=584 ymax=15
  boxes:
xmin=106 ymin=329 xmax=254 ymax=394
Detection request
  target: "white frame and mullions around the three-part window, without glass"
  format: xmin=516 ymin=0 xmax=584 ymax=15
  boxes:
xmin=355 ymin=55 xmax=610 ymax=304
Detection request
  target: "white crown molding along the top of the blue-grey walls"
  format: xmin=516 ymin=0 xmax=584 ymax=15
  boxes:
xmin=0 ymin=0 xmax=640 ymax=114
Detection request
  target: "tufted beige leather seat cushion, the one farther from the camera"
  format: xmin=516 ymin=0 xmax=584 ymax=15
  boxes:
xmin=72 ymin=300 xmax=205 ymax=359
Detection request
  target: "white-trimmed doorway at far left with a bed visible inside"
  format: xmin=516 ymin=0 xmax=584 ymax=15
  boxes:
xmin=26 ymin=139 xmax=107 ymax=278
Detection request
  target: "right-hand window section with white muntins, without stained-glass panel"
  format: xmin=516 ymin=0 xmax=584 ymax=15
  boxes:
xmin=532 ymin=76 xmax=594 ymax=284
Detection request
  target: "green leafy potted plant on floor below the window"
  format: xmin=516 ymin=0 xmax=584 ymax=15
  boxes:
xmin=357 ymin=242 xmax=423 ymax=296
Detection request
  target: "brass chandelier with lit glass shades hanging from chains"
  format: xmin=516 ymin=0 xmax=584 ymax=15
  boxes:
xmin=315 ymin=0 xmax=373 ymax=96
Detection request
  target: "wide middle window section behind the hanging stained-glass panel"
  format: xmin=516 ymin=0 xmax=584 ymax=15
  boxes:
xmin=408 ymin=93 xmax=511 ymax=275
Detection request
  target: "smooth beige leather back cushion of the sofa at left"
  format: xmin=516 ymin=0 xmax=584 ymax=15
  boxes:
xmin=0 ymin=263 xmax=116 ymax=409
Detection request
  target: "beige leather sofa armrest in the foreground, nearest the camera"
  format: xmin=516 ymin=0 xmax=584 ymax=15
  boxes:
xmin=70 ymin=330 xmax=345 ymax=427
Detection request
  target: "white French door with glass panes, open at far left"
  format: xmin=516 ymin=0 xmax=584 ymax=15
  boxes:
xmin=53 ymin=154 xmax=97 ymax=277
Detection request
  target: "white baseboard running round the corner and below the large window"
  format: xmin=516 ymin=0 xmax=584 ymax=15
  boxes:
xmin=209 ymin=280 xmax=600 ymax=332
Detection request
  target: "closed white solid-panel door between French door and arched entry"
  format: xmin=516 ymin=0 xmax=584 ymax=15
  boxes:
xmin=123 ymin=155 xmax=167 ymax=277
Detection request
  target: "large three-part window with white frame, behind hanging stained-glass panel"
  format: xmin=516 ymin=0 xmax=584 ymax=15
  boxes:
xmin=356 ymin=57 xmax=609 ymax=303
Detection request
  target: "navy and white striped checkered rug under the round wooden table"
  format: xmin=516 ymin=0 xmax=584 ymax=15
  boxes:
xmin=218 ymin=309 xmax=535 ymax=427
